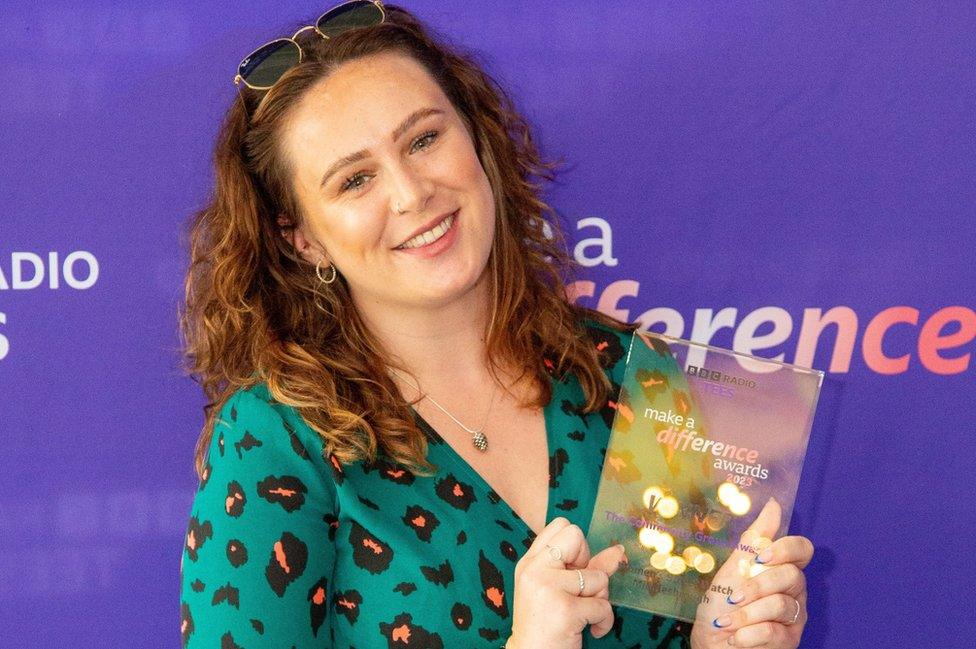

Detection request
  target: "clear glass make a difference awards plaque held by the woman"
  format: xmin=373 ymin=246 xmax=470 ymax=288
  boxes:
xmin=587 ymin=333 xmax=823 ymax=621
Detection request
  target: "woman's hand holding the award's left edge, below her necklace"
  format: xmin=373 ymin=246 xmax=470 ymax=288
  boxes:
xmin=505 ymin=516 xmax=626 ymax=649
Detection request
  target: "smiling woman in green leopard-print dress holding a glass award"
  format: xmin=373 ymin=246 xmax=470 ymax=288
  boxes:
xmin=181 ymin=2 xmax=812 ymax=649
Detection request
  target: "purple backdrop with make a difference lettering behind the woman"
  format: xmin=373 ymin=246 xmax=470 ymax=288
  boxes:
xmin=0 ymin=0 xmax=976 ymax=649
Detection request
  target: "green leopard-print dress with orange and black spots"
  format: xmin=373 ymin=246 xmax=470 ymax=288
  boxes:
xmin=180 ymin=320 xmax=690 ymax=649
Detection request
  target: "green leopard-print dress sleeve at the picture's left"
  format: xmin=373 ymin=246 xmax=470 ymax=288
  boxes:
xmin=180 ymin=389 xmax=336 ymax=649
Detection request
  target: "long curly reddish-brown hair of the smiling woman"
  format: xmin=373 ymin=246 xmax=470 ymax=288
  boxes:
xmin=179 ymin=5 xmax=633 ymax=476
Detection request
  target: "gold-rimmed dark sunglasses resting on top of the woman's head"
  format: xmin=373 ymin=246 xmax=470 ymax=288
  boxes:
xmin=234 ymin=0 xmax=386 ymax=90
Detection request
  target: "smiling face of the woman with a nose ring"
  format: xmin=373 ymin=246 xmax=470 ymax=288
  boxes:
xmin=283 ymin=53 xmax=495 ymax=307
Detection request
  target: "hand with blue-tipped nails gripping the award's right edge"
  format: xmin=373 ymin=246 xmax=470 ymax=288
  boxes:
xmin=691 ymin=499 xmax=813 ymax=649
